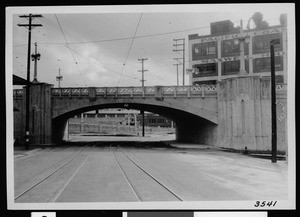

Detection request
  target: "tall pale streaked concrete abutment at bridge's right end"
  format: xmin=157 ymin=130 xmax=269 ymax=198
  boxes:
xmin=217 ymin=76 xmax=287 ymax=151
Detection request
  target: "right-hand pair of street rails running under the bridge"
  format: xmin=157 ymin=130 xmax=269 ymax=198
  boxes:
xmin=110 ymin=145 xmax=183 ymax=201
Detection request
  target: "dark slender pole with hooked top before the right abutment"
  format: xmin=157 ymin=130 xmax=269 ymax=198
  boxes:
xmin=270 ymin=39 xmax=280 ymax=163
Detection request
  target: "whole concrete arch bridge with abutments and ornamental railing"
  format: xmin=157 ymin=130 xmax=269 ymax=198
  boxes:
xmin=13 ymin=76 xmax=286 ymax=150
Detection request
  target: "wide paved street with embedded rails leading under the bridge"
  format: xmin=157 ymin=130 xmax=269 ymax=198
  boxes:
xmin=14 ymin=137 xmax=288 ymax=203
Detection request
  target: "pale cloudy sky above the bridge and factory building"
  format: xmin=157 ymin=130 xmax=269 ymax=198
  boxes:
xmin=7 ymin=3 xmax=290 ymax=87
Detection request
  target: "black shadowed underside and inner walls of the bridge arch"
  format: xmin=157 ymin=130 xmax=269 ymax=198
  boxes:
xmin=52 ymin=103 xmax=217 ymax=145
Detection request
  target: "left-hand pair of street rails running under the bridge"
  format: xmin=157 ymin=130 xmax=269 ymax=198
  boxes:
xmin=14 ymin=142 xmax=95 ymax=202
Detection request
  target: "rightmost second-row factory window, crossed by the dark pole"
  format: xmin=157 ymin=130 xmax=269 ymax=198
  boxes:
xmin=253 ymin=56 xmax=283 ymax=72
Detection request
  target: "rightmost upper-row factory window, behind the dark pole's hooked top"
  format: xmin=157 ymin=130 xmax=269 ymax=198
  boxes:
xmin=253 ymin=34 xmax=282 ymax=54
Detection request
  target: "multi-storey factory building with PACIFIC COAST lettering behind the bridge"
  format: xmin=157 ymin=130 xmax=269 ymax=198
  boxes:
xmin=189 ymin=13 xmax=287 ymax=85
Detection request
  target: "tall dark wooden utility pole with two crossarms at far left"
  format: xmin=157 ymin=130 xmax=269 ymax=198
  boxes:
xmin=18 ymin=14 xmax=43 ymax=149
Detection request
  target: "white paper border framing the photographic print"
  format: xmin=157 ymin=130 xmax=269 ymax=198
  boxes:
xmin=5 ymin=3 xmax=296 ymax=210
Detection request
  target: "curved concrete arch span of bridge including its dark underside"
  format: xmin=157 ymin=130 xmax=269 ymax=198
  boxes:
xmin=52 ymin=99 xmax=217 ymax=145
